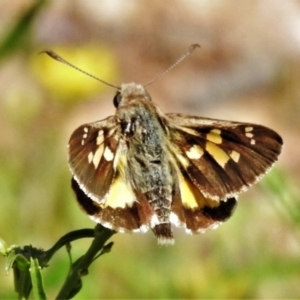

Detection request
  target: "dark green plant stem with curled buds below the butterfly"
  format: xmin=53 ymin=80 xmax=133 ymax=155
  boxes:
xmin=0 ymin=224 xmax=115 ymax=300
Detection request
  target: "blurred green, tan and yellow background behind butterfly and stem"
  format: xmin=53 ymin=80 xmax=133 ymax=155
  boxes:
xmin=0 ymin=0 xmax=300 ymax=299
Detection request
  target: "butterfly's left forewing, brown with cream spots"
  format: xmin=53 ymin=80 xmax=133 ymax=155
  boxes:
xmin=68 ymin=116 xmax=119 ymax=203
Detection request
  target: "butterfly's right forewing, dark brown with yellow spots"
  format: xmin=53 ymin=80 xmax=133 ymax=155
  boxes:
xmin=166 ymin=114 xmax=282 ymax=200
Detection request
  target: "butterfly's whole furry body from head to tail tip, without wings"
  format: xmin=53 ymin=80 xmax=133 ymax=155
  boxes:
xmin=116 ymin=84 xmax=175 ymax=244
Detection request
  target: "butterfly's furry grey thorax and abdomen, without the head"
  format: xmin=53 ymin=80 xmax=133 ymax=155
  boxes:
xmin=121 ymin=102 xmax=174 ymax=243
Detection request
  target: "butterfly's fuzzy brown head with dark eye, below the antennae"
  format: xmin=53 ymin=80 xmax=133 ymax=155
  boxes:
xmin=113 ymin=82 xmax=151 ymax=108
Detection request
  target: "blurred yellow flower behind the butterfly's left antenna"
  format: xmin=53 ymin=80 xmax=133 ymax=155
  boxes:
xmin=31 ymin=45 xmax=119 ymax=102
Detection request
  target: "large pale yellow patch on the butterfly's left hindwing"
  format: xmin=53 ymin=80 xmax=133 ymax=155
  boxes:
xmin=103 ymin=176 xmax=136 ymax=208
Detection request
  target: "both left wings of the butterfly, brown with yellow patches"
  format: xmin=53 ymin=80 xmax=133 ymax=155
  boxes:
xmin=69 ymin=117 xmax=157 ymax=232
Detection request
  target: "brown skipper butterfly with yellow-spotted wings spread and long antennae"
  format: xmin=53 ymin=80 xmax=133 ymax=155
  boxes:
xmin=45 ymin=45 xmax=283 ymax=245
